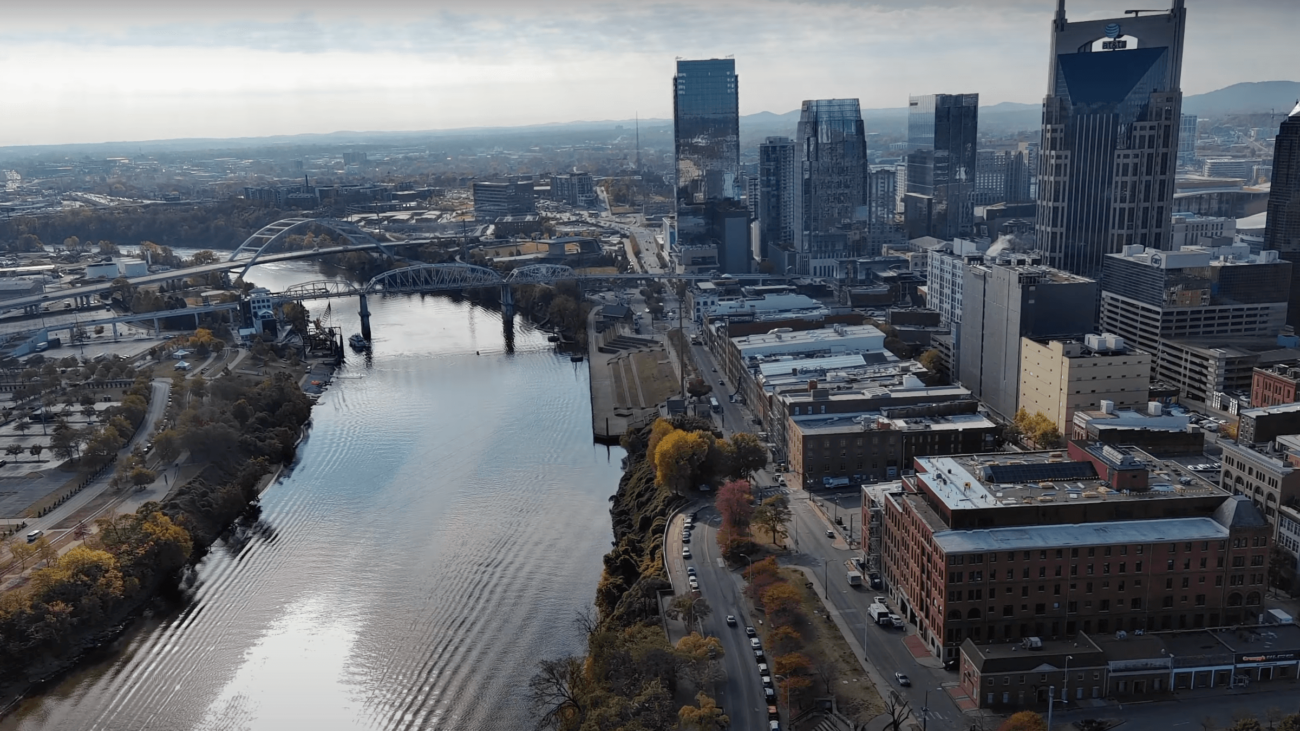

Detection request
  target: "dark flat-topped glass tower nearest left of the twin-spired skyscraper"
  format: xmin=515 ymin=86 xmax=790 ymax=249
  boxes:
xmin=904 ymin=94 xmax=979 ymax=239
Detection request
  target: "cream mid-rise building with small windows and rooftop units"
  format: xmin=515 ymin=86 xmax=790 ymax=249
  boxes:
xmin=1019 ymin=334 xmax=1152 ymax=434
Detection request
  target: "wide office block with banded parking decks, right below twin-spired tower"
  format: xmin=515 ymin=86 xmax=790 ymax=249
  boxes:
xmin=1100 ymin=245 xmax=1292 ymax=402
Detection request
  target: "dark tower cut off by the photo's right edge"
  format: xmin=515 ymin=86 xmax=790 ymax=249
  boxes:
xmin=1264 ymin=103 xmax=1300 ymax=328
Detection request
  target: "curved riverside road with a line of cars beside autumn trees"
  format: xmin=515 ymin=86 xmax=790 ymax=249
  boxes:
xmin=666 ymin=507 xmax=767 ymax=731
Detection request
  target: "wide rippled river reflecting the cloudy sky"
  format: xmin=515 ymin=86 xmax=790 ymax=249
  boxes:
xmin=0 ymin=264 xmax=623 ymax=731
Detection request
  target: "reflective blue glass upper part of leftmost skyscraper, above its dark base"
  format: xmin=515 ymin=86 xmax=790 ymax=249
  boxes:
xmin=672 ymin=59 xmax=740 ymax=206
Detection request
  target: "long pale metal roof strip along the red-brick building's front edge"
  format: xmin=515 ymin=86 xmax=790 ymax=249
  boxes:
xmin=935 ymin=518 xmax=1227 ymax=553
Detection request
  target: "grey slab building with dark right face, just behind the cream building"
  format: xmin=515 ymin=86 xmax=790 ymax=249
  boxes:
xmin=957 ymin=255 xmax=1097 ymax=419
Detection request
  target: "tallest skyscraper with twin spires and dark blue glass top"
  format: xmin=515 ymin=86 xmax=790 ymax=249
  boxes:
xmin=1035 ymin=0 xmax=1187 ymax=277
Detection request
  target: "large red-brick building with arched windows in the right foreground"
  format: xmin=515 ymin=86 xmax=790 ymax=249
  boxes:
xmin=863 ymin=442 xmax=1270 ymax=659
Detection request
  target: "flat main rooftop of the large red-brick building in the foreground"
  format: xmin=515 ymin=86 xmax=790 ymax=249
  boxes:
xmin=917 ymin=447 xmax=1227 ymax=511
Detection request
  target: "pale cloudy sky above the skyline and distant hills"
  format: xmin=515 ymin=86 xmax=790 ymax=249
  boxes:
xmin=0 ymin=0 xmax=1300 ymax=146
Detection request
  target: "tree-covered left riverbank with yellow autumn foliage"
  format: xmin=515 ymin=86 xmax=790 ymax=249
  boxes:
xmin=0 ymin=351 xmax=322 ymax=718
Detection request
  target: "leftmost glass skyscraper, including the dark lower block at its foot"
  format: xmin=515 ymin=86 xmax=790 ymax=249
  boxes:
xmin=672 ymin=59 xmax=753 ymax=273
